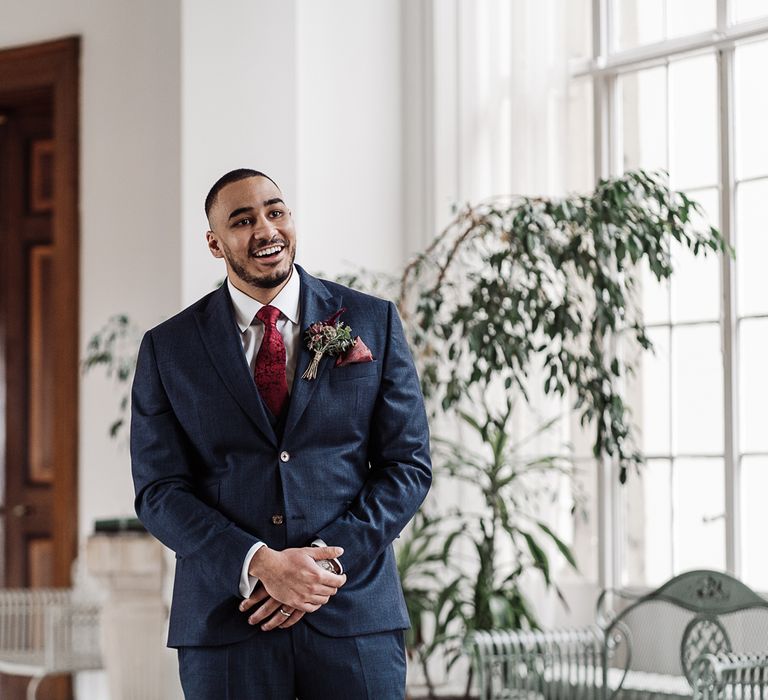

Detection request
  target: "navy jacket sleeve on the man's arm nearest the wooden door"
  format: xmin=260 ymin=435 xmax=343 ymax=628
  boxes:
xmin=131 ymin=331 xmax=259 ymax=596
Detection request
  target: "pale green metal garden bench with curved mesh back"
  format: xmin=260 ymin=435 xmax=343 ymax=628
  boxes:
xmin=467 ymin=571 xmax=768 ymax=700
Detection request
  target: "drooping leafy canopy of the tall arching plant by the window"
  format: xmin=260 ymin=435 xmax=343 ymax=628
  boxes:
xmin=398 ymin=170 xmax=733 ymax=483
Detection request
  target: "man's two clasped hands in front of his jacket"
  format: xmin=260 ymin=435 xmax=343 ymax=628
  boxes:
xmin=240 ymin=547 xmax=347 ymax=632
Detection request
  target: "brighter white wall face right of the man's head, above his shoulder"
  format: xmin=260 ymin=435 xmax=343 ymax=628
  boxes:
xmin=295 ymin=0 xmax=404 ymax=274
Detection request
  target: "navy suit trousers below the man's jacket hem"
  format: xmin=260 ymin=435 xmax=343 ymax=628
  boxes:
xmin=178 ymin=621 xmax=406 ymax=700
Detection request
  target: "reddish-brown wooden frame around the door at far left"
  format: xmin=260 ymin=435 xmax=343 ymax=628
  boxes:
xmin=0 ymin=37 xmax=80 ymax=586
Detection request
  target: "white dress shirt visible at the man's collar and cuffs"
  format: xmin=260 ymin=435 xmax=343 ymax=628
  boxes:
xmin=227 ymin=267 xmax=341 ymax=598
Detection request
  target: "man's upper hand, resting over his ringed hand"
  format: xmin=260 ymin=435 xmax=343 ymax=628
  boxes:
xmin=248 ymin=547 xmax=347 ymax=619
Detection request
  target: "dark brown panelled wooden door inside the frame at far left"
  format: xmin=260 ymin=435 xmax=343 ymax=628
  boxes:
xmin=0 ymin=87 xmax=56 ymax=588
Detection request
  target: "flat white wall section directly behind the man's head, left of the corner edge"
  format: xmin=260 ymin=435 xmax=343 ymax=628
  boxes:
xmin=181 ymin=0 xmax=297 ymax=306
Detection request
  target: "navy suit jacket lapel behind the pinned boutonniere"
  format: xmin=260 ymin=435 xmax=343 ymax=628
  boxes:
xmin=284 ymin=265 xmax=341 ymax=436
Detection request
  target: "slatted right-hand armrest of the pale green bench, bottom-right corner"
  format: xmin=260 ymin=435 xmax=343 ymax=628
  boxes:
xmin=693 ymin=652 xmax=768 ymax=700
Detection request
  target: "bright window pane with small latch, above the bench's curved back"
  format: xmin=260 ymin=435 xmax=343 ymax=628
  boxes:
xmin=672 ymin=459 xmax=725 ymax=574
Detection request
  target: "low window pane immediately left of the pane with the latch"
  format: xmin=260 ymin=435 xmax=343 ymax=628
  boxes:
xmin=621 ymin=459 xmax=672 ymax=586
